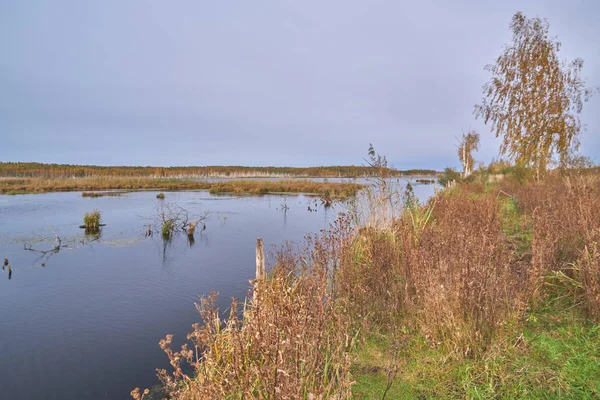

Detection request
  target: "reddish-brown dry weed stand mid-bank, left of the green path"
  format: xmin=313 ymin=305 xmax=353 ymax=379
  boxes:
xmin=338 ymin=194 xmax=523 ymax=355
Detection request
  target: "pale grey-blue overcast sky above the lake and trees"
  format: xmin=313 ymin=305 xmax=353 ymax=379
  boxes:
xmin=0 ymin=0 xmax=600 ymax=169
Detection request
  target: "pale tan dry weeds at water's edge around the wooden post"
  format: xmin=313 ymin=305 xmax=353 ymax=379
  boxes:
xmin=132 ymin=226 xmax=356 ymax=399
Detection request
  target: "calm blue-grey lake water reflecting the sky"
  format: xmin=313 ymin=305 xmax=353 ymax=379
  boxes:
xmin=0 ymin=182 xmax=433 ymax=399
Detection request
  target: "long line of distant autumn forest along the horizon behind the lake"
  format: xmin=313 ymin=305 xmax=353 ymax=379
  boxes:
xmin=0 ymin=162 xmax=438 ymax=178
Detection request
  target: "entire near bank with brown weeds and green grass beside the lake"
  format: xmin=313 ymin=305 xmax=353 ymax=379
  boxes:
xmin=132 ymin=176 xmax=600 ymax=399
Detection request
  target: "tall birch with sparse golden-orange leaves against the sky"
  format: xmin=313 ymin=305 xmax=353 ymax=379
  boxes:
xmin=475 ymin=12 xmax=597 ymax=178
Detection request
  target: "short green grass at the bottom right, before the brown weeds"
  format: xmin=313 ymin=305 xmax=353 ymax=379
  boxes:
xmin=353 ymin=304 xmax=600 ymax=399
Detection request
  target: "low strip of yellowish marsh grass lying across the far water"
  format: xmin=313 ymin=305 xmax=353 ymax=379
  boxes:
xmin=0 ymin=177 xmax=362 ymax=198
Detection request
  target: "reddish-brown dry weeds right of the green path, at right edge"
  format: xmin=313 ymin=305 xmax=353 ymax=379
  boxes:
xmin=504 ymin=174 xmax=600 ymax=321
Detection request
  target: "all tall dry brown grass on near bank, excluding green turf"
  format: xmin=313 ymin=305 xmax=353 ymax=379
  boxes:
xmin=132 ymin=173 xmax=600 ymax=399
